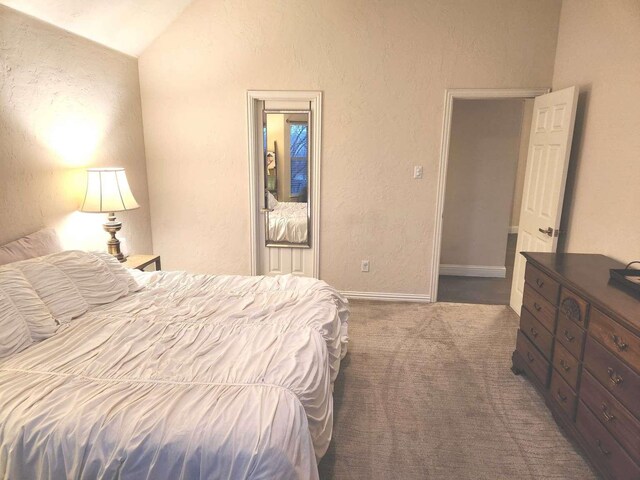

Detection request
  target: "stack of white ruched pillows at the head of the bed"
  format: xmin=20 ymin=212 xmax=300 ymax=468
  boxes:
xmin=0 ymin=250 xmax=140 ymax=359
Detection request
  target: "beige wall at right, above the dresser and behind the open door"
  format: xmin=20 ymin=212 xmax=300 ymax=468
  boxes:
xmin=553 ymin=0 xmax=640 ymax=261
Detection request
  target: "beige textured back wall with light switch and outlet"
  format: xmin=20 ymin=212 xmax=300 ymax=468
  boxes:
xmin=139 ymin=0 xmax=560 ymax=294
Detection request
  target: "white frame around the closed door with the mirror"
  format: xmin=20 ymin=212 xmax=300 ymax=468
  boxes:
xmin=247 ymin=90 xmax=322 ymax=278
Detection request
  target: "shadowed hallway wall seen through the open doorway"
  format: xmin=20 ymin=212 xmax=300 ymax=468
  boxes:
xmin=440 ymin=99 xmax=524 ymax=267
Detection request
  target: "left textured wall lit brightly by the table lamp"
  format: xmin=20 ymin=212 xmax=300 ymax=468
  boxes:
xmin=0 ymin=6 xmax=151 ymax=252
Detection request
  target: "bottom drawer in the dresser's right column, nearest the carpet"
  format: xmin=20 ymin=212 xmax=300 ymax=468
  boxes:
xmin=576 ymin=402 xmax=640 ymax=480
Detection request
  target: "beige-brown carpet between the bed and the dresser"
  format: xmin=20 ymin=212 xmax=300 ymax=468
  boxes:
xmin=320 ymin=301 xmax=597 ymax=480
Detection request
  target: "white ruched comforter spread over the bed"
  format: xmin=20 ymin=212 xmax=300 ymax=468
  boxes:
xmin=0 ymin=273 xmax=348 ymax=479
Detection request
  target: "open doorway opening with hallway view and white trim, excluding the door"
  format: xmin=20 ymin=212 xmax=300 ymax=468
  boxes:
xmin=431 ymin=89 xmax=549 ymax=304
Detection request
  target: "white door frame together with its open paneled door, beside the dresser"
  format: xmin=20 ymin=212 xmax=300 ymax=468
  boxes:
xmin=431 ymin=86 xmax=579 ymax=313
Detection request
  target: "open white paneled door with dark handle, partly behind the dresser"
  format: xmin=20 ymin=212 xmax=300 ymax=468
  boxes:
xmin=510 ymin=87 xmax=578 ymax=315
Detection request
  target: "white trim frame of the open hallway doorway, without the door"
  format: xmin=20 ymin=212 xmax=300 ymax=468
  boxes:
xmin=430 ymin=88 xmax=551 ymax=302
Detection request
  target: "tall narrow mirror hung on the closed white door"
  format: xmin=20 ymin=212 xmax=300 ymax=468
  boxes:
xmin=262 ymin=110 xmax=311 ymax=248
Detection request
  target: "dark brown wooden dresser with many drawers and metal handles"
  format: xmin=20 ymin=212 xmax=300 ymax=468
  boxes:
xmin=513 ymin=253 xmax=640 ymax=480
